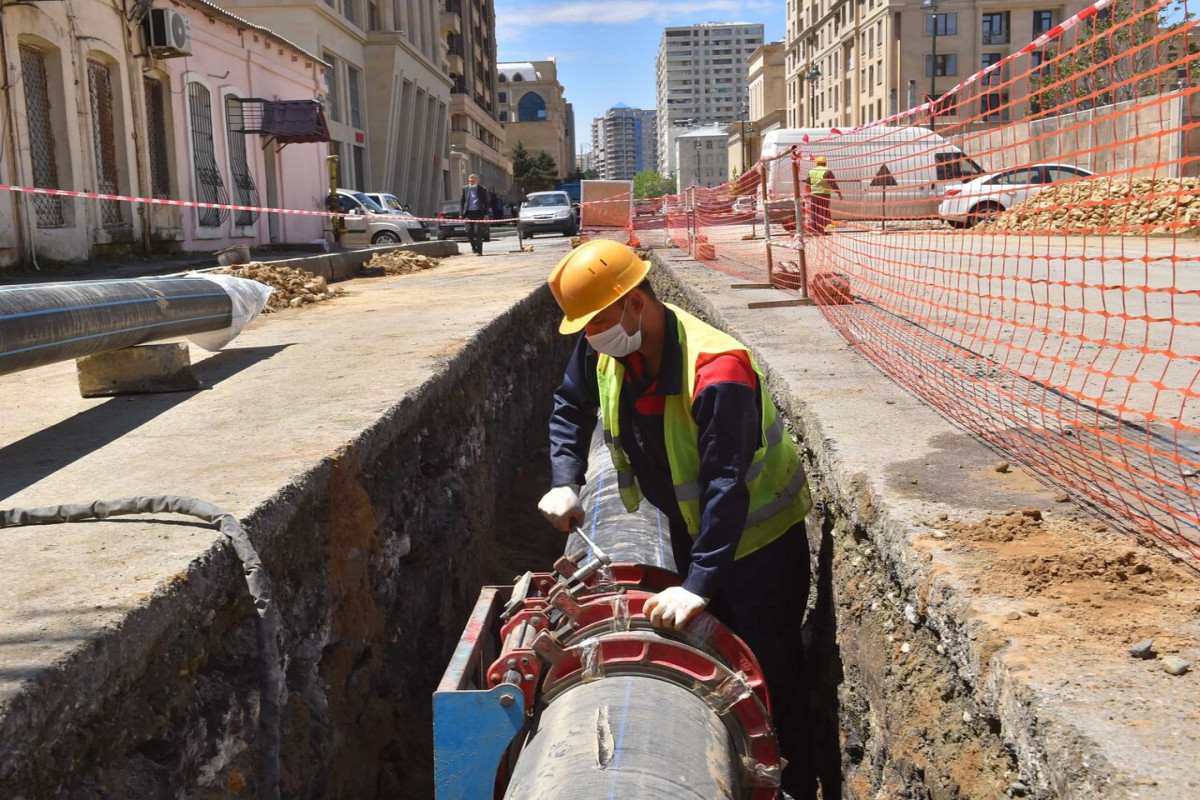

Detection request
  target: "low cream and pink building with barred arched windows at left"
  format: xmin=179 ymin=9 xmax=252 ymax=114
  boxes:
xmin=0 ymin=0 xmax=329 ymax=267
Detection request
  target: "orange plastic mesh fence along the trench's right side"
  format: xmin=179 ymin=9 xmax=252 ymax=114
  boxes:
xmin=635 ymin=0 xmax=1200 ymax=566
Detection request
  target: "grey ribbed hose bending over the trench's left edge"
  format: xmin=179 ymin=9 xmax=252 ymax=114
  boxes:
xmin=0 ymin=495 xmax=283 ymax=800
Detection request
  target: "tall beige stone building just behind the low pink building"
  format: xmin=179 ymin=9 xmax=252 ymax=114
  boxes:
xmin=221 ymin=0 xmax=451 ymax=215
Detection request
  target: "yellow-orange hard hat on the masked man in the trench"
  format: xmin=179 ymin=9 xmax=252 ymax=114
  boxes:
xmin=546 ymin=239 xmax=650 ymax=333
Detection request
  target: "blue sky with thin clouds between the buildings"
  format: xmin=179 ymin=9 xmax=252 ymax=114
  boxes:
xmin=496 ymin=0 xmax=787 ymax=150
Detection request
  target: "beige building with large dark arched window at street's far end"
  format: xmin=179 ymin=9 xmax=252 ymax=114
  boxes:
xmin=497 ymin=59 xmax=575 ymax=176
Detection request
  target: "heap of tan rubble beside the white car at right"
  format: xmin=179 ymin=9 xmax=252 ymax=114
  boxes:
xmin=978 ymin=175 xmax=1200 ymax=235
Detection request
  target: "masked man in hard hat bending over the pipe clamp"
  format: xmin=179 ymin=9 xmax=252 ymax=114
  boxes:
xmin=538 ymin=239 xmax=815 ymax=798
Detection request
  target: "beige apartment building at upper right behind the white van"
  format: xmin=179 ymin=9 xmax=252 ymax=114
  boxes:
xmin=785 ymin=0 xmax=1088 ymax=127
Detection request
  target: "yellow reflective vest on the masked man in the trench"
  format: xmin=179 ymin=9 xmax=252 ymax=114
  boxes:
xmin=596 ymin=303 xmax=812 ymax=558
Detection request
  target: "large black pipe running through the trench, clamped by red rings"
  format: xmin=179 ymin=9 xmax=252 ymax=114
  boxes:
xmin=504 ymin=426 xmax=743 ymax=800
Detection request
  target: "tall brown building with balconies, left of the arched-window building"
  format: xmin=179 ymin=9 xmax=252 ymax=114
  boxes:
xmin=446 ymin=0 xmax=512 ymax=199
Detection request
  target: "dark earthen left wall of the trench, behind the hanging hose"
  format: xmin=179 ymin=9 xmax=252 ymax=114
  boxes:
xmin=0 ymin=287 xmax=570 ymax=800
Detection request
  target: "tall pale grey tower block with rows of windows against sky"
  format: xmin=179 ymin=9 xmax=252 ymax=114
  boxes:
xmin=655 ymin=23 xmax=763 ymax=176
